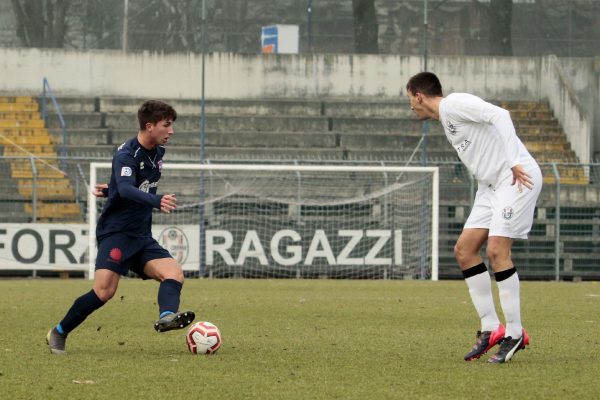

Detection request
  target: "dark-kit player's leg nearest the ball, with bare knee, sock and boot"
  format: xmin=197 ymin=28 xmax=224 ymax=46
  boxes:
xmin=143 ymin=257 xmax=196 ymax=332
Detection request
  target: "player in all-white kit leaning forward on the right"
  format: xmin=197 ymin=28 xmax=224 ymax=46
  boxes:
xmin=406 ymin=72 xmax=542 ymax=363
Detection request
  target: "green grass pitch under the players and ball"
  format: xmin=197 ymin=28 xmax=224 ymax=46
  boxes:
xmin=0 ymin=279 xmax=600 ymax=400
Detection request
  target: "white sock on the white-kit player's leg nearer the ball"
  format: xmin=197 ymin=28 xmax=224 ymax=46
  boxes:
xmin=465 ymin=270 xmax=500 ymax=332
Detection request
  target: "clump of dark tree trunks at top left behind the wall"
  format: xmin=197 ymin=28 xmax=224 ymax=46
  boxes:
xmin=12 ymin=0 xmax=70 ymax=47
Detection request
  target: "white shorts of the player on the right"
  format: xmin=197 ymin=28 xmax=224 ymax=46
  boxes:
xmin=464 ymin=166 xmax=542 ymax=239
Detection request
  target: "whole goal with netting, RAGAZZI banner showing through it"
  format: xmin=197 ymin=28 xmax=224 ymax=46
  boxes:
xmin=88 ymin=163 xmax=439 ymax=280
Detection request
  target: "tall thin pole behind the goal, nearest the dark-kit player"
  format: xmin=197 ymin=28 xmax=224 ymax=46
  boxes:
xmin=198 ymin=0 xmax=206 ymax=276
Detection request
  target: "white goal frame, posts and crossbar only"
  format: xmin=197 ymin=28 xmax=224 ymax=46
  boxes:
xmin=88 ymin=162 xmax=440 ymax=281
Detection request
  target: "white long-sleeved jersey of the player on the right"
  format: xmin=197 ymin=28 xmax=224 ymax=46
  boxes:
xmin=439 ymin=93 xmax=537 ymax=187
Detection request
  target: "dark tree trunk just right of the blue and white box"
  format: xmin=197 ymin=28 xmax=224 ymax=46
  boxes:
xmin=352 ymin=0 xmax=379 ymax=54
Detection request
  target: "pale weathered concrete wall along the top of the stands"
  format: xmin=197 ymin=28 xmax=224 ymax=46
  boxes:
xmin=0 ymin=49 xmax=540 ymax=100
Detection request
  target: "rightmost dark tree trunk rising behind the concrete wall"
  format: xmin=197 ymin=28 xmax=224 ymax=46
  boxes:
xmin=490 ymin=0 xmax=512 ymax=56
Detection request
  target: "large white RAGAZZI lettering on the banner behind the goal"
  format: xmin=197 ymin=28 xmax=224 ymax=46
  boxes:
xmin=206 ymin=229 xmax=402 ymax=266
